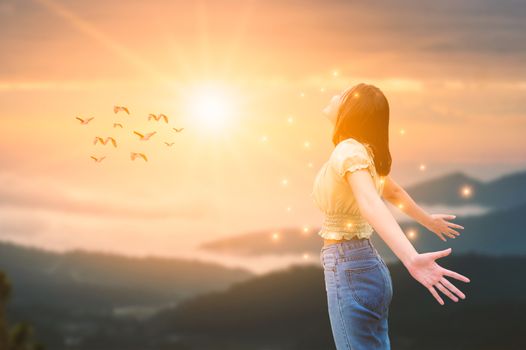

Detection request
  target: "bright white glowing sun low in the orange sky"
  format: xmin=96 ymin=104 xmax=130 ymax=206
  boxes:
xmin=185 ymin=82 xmax=237 ymax=130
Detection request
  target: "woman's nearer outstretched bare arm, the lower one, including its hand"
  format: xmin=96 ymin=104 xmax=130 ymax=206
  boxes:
xmin=344 ymin=168 xmax=469 ymax=305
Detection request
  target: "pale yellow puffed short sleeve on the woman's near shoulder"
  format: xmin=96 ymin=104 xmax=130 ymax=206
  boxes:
xmin=331 ymin=141 xmax=372 ymax=177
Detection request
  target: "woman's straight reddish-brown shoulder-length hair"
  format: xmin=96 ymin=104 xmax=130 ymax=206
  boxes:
xmin=332 ymin=83 xmax=392 ymax=176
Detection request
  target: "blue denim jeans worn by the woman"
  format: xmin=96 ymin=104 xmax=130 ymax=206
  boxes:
xmin=320 ymin=238 xmax=393 ymax=350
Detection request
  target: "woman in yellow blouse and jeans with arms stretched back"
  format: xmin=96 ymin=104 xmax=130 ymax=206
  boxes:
xmin=311 ymin=83 xmax=469 ymax=350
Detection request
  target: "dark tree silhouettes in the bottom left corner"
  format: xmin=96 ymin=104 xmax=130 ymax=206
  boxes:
xmin=0 ymin=271 xmax=45 ymax=350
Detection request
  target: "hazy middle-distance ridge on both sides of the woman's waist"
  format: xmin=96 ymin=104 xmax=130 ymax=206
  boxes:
xmin=200 ymin=203 xmax=526 ymax=261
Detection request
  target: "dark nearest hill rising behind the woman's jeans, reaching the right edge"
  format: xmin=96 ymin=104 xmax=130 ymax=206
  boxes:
xmin=145 ymin=254 xmax=526 ymax=350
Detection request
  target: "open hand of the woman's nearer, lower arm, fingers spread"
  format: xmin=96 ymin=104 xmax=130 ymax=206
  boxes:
xmin=406 ymin=248 xmax=470 ymax=305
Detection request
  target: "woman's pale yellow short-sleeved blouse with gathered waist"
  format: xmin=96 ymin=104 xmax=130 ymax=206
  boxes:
xmin=310 ymin=138 xmax=385 ymax=239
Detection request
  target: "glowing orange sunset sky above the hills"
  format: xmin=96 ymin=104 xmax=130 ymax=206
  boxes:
xmin=0 ymin=0 xmax=526 ymax=274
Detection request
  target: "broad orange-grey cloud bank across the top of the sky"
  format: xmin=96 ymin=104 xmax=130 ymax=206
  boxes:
xmin=0 ymin=0 xmax=526 ymax=80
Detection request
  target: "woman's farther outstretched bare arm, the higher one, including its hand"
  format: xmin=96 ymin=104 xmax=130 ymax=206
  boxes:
xmin=382 ymin=176 xmax=464 ymax=241
